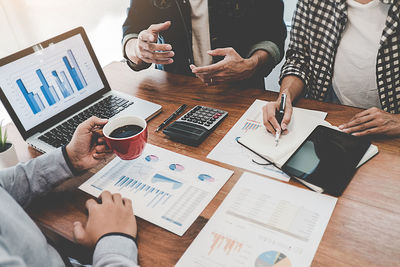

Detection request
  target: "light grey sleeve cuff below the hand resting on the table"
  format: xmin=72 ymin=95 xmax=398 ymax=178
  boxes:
xmin=93 ymin=238 xmax=138 ymax=267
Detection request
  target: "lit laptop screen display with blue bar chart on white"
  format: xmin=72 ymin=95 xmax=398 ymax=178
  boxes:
xmin=0 ymin=31 xmax=105 ymax=131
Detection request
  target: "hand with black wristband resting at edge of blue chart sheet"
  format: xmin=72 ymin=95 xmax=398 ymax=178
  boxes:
xmin=73 ymin=191 xmax=137 ymax=248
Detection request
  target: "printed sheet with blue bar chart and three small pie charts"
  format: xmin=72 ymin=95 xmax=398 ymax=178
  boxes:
xmin=79 ymin=144 xmax=233 ymax=236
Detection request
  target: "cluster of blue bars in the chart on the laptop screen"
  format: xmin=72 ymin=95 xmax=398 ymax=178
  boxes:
xmin=16 ymin=49 xmax=88 ymax=114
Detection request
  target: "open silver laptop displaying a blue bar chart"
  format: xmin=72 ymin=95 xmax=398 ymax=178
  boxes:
xmin=0 ymin=27 xmax=162 ymax=153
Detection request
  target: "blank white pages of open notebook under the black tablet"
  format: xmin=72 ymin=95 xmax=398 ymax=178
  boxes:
xmin=238 ymin=108 xmax=378 ymax=168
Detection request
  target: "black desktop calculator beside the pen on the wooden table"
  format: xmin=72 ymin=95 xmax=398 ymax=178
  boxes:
xmin=163 ymin=106 xmax=228 ymax=146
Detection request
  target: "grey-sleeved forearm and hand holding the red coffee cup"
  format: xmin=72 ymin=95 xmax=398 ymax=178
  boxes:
xmin=0 ymin=117 xmax=110 ymax=207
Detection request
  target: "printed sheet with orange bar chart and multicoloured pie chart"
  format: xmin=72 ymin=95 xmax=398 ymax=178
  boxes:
xmin=176 ymin=173 xmax=337 ymax=267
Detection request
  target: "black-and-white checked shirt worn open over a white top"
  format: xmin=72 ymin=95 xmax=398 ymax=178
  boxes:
xmin=281 ymin=0 xmax=400 ymax=113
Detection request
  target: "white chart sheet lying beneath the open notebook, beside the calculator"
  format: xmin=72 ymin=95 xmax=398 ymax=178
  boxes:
xmin=207 ymin=99 xmax=327 ymax=181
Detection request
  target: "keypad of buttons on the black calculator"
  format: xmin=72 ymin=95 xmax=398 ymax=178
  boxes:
xmin=178 ymin=106 xmax=227 ymax=129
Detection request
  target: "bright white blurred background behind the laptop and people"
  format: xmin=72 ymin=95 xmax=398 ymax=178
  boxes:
xmin=0 ymin=0 xmax=297 ymax=123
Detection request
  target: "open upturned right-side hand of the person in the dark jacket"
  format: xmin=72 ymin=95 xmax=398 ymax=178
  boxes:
xmin=190 ymin=47 xmax=257 ymax=85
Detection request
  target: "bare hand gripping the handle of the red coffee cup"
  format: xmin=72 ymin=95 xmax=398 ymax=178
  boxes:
xmin=66 ymin=117 xmax=112 ymax=171
